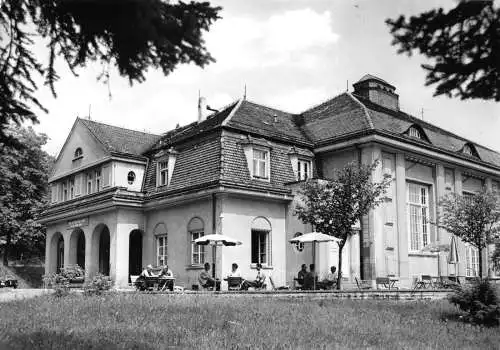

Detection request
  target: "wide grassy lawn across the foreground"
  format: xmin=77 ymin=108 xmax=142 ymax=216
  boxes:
xmin=0 ymin=293 xmax=500 ymax=349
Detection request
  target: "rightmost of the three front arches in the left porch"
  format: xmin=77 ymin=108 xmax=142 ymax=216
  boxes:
xmin=92 ymin=224 xmax=111 ymax=276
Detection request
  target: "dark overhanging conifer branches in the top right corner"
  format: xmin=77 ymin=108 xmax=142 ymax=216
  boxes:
xmin=386 ymin=0 xmax=500 ymax=102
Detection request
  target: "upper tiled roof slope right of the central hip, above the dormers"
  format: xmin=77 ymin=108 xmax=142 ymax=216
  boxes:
xmin=227 ymin=100 xmax=312 ymax=145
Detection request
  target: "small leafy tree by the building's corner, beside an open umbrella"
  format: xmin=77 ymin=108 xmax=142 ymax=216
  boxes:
xmin=295 ymin=161 xmax=391 ymax=289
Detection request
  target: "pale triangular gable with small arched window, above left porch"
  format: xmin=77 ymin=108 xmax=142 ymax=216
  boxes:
xmin=51 ymin=119 xmax=109 ymax=177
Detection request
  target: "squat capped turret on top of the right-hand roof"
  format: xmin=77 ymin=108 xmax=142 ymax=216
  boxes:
xmin=352 ymin=74 xmax=399 ymax=111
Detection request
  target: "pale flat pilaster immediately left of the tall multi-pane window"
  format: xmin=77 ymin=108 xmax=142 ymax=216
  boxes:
xmin=396 ymin=153 xmax=412 ymax=285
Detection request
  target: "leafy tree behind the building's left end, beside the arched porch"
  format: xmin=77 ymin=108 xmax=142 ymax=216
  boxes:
xmin=0 ymin=125 xmax=53 ymax=265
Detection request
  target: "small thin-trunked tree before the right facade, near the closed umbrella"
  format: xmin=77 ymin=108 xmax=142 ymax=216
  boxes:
xmin=438 ymin=190 xmax=500 ymax=278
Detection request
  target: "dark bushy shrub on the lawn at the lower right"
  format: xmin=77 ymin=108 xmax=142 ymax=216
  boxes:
xmin=449 ymin=280 xmax=500 ymax=327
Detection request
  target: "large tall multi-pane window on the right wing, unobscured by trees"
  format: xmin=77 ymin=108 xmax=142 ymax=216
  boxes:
xmin=406 ymin=183 xmax=430 ymax=251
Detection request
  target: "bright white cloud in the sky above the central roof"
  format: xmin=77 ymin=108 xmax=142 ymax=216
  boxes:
xmin=207 ymin=8 xmax=339 ymax=71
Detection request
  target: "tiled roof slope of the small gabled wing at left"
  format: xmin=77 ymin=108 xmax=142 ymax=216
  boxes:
xmin=79 ymin=119 xmax=160 ymax=156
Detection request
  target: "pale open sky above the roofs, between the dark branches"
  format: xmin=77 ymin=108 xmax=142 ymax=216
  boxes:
xmin=35 ymin=0 xmax=500 ymax=155
